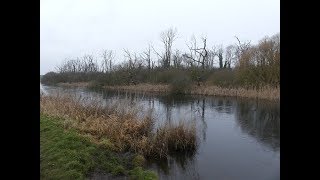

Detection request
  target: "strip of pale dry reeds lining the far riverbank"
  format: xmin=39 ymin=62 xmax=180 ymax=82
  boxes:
xmin=57 ymin=82 xmax=280 ymax=101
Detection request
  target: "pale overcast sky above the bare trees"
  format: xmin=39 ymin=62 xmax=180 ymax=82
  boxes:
xmin=40 ymin=0 xmax=280 ymax=74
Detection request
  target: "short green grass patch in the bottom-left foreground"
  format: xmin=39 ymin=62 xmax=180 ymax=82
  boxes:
xmin=40 ymin=113 xmax=157 ymax=179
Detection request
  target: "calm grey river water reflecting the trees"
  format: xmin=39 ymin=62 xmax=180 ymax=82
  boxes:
xmin=43 ymin=86 xmax=280 ymax=180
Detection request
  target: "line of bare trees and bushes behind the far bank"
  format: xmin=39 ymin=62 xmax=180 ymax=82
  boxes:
xmin=41 ymin=28 xmax=280 ymax=88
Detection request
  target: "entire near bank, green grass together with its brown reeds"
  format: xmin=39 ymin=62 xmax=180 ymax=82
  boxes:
xmin=40 ymin=94 xmax=197 ymax=179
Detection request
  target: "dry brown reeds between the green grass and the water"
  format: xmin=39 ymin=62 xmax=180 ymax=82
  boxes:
xmin=40 ymin=94 xmax=197 ymax=158
